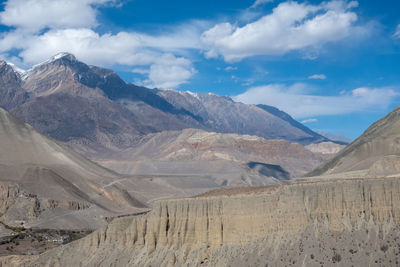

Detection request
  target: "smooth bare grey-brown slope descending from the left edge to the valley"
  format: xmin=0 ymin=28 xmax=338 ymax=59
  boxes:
xmin=0 ymin=109 xmax=145 ymax=229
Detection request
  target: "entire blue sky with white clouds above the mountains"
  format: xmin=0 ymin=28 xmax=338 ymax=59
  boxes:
xmin=0 ymin=0 xmax=400 ymax=139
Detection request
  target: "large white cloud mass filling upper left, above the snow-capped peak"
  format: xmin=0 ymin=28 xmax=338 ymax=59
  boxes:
xmin=0 ymin=0 xmax=205 ymax=88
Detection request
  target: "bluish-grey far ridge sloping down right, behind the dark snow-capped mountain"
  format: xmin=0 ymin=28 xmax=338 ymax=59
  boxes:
xmin=158 ymin=90 xmax=329 ymax=144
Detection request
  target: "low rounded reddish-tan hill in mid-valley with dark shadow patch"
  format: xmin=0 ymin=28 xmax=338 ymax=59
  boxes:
xmin=94 ymin=129 xmax=326 ymax=186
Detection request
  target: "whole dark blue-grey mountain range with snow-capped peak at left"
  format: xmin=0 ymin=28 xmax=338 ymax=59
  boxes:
xmin=0 ymin=53 xmax=334 ymax=157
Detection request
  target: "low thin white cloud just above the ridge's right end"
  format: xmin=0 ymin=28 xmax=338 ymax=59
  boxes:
xmin=233 ymin=84 xmax=400 ymax=118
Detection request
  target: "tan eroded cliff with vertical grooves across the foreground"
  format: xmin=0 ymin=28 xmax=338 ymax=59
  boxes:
xmin=10 ymin=178 xmax=400 ymax=266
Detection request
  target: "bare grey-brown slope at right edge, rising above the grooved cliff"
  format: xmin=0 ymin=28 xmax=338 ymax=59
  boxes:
xmin=308 ymin=106 xmax=400 ymax=177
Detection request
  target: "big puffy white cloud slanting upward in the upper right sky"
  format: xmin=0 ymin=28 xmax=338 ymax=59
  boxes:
xmin=201 ymin=1 xmax=358 ymax=61
